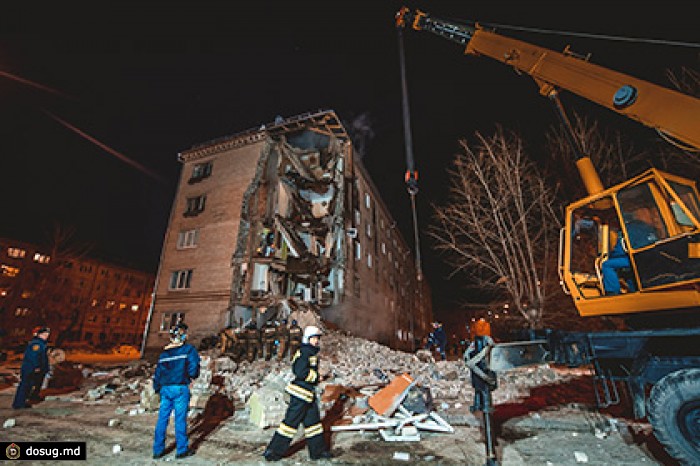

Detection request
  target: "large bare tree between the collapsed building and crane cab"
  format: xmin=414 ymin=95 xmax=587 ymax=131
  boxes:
xmin=428 ymin=127 xmax=560 ymax=327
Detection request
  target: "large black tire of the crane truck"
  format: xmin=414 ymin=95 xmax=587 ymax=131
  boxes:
xmin=649 ymin=369 xmax=700 ymax=465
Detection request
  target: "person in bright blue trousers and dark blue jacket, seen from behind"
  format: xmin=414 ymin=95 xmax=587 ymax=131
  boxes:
xmin=153 ymin=323 xmax=199 ymax=459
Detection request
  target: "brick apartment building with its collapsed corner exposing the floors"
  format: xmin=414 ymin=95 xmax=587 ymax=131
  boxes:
xmin=144 ymin=110 xmax=432 ymax=354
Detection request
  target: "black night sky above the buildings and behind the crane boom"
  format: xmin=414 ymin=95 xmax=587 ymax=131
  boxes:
xmin=0 ymin=0 xmax=700 ymax=310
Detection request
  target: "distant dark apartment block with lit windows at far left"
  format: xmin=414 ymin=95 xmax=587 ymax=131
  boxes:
xmin=0 ymin=238 xmax=155 ymax=347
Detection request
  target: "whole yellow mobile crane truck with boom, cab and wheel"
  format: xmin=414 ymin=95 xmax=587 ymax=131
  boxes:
xmin=396 ymin=7 xmax=700 ymax=464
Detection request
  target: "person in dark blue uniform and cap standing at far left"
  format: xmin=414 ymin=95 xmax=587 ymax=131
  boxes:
xmin=12 ymin=326 xmax=51 ymax=409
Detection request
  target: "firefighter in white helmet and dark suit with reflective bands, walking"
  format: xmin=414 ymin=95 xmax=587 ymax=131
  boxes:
xmin=263 ymin=325 xmax=333 ymax=461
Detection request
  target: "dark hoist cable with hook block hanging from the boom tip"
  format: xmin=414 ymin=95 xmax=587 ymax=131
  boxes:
xmin=396 ymin=27 xmax=423 ymax=281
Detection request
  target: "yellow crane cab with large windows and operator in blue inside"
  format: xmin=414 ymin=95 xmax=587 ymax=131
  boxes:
xmin=559 ymin=169 xmax=700 ymax=316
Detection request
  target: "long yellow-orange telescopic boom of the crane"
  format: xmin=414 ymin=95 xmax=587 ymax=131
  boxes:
xmin=396 ymin=7 xmax=700 ymax=148
